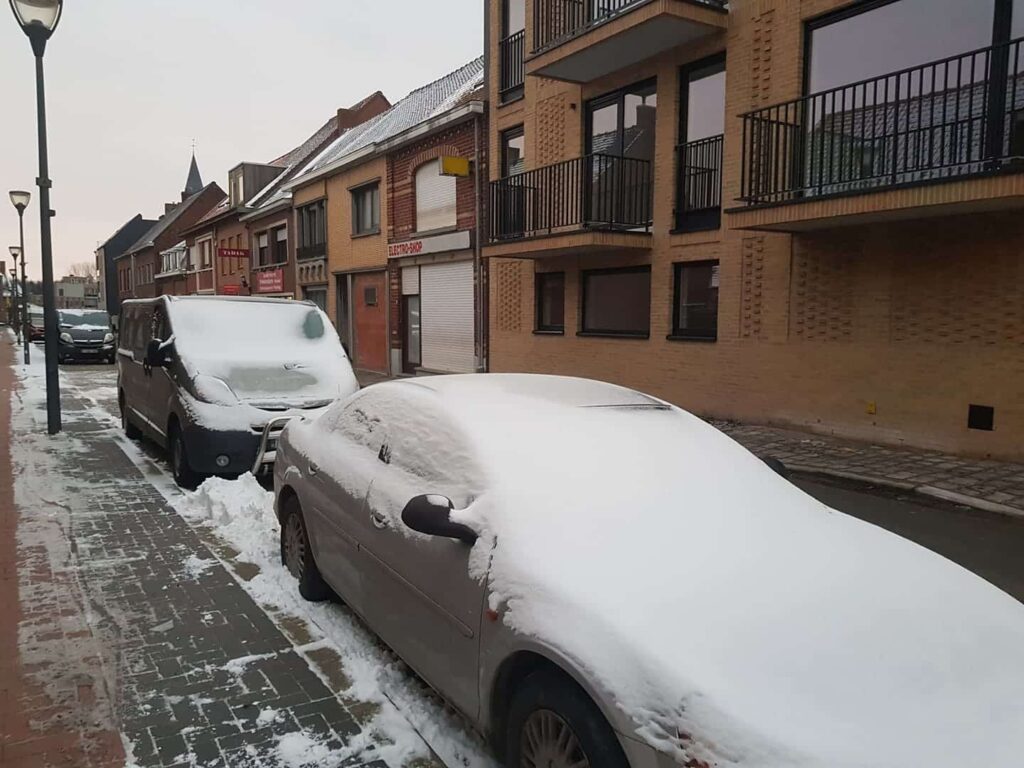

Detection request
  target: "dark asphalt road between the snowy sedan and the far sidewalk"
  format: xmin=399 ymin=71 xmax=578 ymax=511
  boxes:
xmin=794 ymin=476 xmax=1024 ymax=602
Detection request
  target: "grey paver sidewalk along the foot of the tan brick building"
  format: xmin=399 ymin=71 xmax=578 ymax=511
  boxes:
xmin=715 ymin=422 xmax=1024 ymax=515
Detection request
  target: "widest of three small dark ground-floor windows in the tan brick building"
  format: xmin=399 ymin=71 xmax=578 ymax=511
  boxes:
xmin=581 ymin=266 xmax=650 ymax=338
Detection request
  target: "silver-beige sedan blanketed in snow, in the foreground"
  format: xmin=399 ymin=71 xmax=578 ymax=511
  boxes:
xmin=274 ymin=375 xmax=1024 ymax=768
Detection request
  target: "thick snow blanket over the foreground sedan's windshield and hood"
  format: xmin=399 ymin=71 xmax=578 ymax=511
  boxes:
xmin=432 ymin=380 xmax=1024 ymax=768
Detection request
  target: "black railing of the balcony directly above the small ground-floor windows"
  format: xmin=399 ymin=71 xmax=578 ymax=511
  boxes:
xmin=490 ymin=155 xmax=652 ymax=241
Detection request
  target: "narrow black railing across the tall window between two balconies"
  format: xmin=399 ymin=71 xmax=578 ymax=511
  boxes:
xmin=676 ymin=135 xmax=724 ymax=231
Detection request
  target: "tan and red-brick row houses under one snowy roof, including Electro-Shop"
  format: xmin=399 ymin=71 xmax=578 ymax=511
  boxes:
xmin=286 ymin=57 xmax=486 ymax=375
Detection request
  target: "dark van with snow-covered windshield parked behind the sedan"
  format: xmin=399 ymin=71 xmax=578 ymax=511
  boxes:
xmin=118 ymin=296 xmax=358 ymax=487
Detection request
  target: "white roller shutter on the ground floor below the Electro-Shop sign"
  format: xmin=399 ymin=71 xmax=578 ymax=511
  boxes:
xmin=420 ymin=261 xmax=475 ymax=374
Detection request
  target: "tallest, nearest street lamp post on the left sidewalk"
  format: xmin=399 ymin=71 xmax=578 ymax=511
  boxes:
xmin=10 ymin=0 xmax=63 ymax=434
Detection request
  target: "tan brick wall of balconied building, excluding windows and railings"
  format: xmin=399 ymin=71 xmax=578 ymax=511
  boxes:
xmin=484 ymin=0 xmax=1024 ymax=460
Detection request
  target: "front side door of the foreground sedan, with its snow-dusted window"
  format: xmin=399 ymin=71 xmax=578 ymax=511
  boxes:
xmin=360 ymin=387 xmax=484 ymax=718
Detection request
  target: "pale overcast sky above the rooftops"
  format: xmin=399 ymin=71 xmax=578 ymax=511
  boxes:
xmin=0 ymin=0 xmax=483 ymax=279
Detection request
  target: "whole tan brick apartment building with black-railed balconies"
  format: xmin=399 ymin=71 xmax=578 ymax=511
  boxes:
xmin=483 ymin=0 xmax=1024 ymax=460
